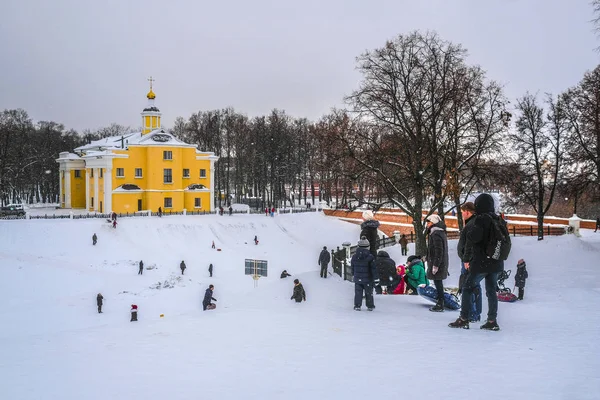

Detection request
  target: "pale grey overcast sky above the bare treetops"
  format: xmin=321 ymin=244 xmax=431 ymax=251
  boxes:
xmin=0 ymin=0 xmax=600 ymax=130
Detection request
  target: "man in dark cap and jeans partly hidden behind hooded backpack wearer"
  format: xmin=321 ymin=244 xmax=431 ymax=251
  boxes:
xmin=456 ymin=201 xmax=481 ymax=322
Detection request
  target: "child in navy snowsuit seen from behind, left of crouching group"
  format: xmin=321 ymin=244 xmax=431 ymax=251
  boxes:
xmin=350 ymin=236 xmax=379 ymax=311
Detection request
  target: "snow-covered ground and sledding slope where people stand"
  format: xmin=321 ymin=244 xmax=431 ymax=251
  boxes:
xmin=0 ymin=213 xmax=600 ymax=400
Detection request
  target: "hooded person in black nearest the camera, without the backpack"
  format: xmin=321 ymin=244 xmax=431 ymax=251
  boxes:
xmin=448 ymin=193 xmax=504 ymax=331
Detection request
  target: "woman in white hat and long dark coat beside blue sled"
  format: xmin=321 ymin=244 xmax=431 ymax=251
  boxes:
xmin=426 ymin=214 xmax=448 ymax=312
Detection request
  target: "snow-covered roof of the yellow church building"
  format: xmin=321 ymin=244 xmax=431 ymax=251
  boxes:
xmin=75 ymin=129 xmax=196 ymax=153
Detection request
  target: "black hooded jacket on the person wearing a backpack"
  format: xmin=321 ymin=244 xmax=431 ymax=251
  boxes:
xmin=467 ymin=193 xmax=504 ymax=274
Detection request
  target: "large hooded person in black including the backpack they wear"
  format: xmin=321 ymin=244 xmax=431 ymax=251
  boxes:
xmin=448 ymin=193 xmax=510 ymax=331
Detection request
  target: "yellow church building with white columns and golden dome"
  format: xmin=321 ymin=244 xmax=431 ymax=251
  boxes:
xmin=56 ymin=80 xmax=218 ymax=213
